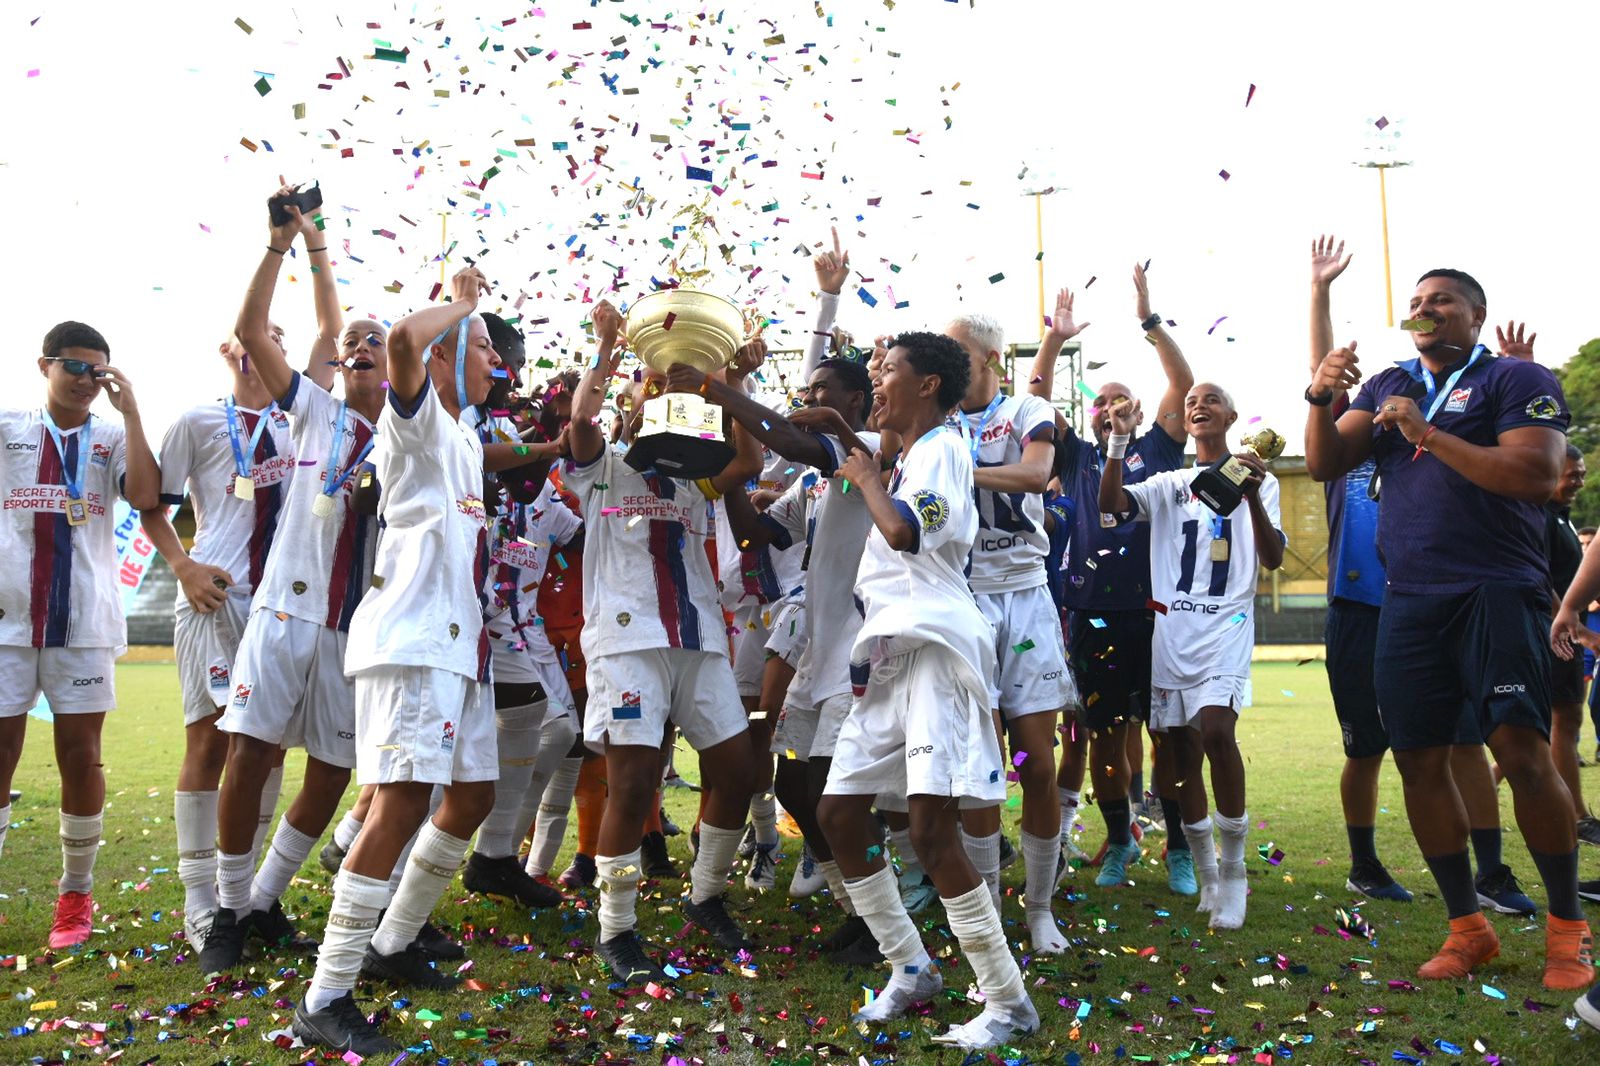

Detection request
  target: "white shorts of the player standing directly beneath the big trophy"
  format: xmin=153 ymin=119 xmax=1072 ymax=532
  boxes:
xmin=584 ymin=648 xmax=746 ymax=752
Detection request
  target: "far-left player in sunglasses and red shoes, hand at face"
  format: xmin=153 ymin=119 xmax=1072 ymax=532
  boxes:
xmin=0 ymin=322 xmax=162 ymax=951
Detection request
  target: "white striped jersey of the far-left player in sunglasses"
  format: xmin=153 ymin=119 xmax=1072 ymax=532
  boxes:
xmin=0 ymin=408 xmax=138 ymax=648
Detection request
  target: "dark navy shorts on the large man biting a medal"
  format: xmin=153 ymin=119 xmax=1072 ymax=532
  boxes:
xmin=1373 ymin=584 xmax=1550 ymax=751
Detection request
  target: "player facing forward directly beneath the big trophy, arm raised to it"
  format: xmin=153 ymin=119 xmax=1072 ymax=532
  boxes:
xmin=565 ymin=301 xmax=762 ymax=984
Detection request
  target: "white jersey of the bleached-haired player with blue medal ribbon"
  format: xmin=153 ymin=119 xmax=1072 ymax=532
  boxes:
xmin=950 ymin=392 xmax=1056 ymax=592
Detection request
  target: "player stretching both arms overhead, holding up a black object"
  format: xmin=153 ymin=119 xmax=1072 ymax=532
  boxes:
xmin=200 ymin=187 xmax=387 ymax=973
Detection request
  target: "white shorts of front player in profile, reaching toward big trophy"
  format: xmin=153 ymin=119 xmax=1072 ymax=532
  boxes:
xmin=822 ymin=643 xmax=1005 ymax=804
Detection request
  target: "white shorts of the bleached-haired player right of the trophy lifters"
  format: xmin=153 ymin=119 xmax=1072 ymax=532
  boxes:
xmin=976 ymin=586 xmax=1078 ymax=722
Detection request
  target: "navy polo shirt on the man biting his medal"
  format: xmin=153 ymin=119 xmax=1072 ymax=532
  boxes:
xmin=1350 ymin=344 xmax=1571 ymax=595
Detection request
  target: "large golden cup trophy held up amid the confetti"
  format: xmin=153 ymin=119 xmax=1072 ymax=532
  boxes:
xmin=626 ymin=288 xmax=744 ymax=480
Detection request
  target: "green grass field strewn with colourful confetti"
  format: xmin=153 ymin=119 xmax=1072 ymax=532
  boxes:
xmin=0 ymin=663 xmax=1600 ymax=1064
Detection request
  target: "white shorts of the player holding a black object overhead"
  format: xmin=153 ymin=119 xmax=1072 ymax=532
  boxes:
xmin=216 ymin=607 xmax=355 ymax=770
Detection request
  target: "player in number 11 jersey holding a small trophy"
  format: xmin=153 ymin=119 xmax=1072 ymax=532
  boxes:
xmin=1099 ymin=383 xmax=1285 ymax=928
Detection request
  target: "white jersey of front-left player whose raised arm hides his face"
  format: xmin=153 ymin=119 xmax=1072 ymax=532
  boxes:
xmin=344 ymin=378 xmax=490 ymax=682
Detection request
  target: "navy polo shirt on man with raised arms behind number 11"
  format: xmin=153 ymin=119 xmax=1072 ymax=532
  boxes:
xmin=1056 ymin=426 xmax=1184 ymax=611
